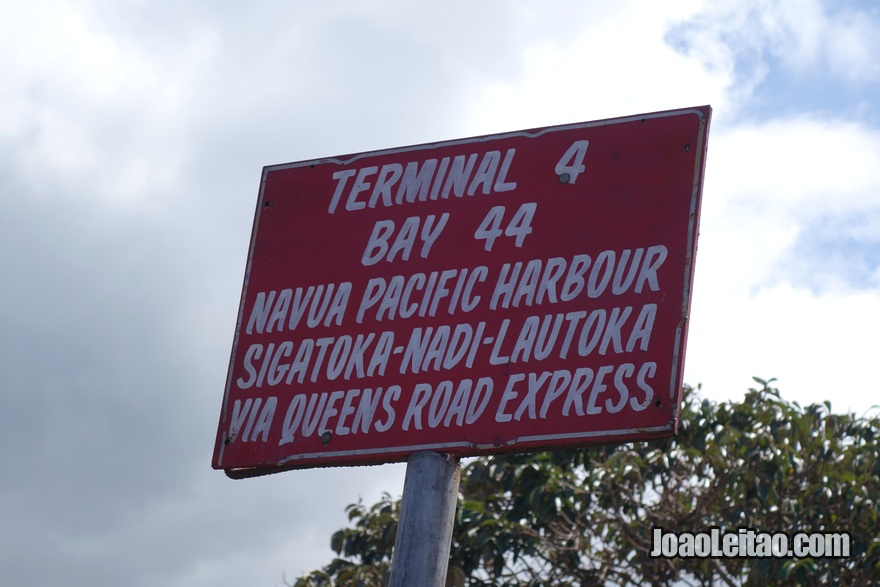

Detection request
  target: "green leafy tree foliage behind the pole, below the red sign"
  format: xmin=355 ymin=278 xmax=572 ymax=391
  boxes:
xmin=294 ymin=379 xmax=880 ymax=587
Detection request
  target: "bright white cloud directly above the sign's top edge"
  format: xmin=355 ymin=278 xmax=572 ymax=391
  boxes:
xmin=468 ymin=3 xmax=730 ymax=133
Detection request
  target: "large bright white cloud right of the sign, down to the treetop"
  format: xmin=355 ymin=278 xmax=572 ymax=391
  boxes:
xmin=686 ymin=112 xmax=880 ymax=412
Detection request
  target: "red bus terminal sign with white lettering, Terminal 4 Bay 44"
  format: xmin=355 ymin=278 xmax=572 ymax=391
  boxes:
xmin=213 ymin=106 xmax=711 ymax=476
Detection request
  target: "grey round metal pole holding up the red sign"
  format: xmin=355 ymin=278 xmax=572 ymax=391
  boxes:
xmin=390 ymin=452 xmax=461 ymax=587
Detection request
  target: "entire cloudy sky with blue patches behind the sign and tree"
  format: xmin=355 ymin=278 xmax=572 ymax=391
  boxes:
xmin=0 ymin=0 xmax=880 ymax=587
